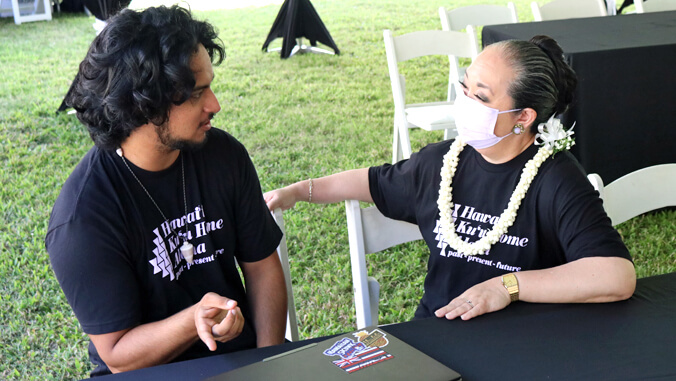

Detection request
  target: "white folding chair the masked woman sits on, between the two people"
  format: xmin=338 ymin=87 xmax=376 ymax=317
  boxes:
xmin=345 ymin=200 xmax=422 ymax=329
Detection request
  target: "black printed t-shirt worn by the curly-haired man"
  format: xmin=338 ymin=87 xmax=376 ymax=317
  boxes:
xmin=45 ymin=129 xmax=281 ymax=374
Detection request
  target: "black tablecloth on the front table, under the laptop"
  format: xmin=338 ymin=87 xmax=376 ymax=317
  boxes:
xmin=96 ymin=273 xmax=676 ymax=381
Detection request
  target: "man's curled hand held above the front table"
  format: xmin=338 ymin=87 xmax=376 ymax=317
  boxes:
xmin=195 ymin=292 xmax=244 ymax=351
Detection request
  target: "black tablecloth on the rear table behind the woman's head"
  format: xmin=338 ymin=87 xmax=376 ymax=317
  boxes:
xmin=482 ymin=12 xmax=676 ymax=184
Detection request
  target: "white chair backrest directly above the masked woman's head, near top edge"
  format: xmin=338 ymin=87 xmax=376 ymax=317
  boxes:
xmin=439 ymin=1 xmax=519 ymax=31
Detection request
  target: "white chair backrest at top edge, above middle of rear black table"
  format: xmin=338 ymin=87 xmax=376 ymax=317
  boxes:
xmin=531 ymin=0 xmax=608 ymax=21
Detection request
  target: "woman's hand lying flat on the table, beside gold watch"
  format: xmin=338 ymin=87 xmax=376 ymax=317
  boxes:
xmin=434 ymin=277 xmax=511 ymax=320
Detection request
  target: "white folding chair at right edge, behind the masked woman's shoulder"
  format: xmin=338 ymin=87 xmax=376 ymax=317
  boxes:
xmin=587 ymin=162 xmax=676 ymax=226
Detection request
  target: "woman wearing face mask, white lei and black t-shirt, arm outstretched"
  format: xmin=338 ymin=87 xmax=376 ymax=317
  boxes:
xmin=265 ymin=36 xmax=636 ymax=320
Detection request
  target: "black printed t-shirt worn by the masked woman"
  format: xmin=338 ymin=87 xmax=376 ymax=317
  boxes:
xmin=369 ymin=141 xmax=631 ymax=317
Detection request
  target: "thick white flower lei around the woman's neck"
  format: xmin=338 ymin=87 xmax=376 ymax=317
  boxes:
xmin=437 ymin=138 xmax=553 ymax=255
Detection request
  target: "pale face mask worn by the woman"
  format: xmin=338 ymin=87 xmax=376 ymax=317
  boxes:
xmin=453 ymin=86 xmax=521 ymax=149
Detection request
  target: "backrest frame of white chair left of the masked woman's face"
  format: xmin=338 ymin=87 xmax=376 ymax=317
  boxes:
xmin=383 ymin=28 xmax=479 ymax=113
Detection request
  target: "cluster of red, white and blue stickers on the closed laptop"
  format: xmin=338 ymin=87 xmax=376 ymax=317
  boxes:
xmin=324 ymin=329 xmax=394 ymax=373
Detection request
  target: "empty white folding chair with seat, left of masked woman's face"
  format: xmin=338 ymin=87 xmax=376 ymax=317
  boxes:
xmin=383 ymin=27 xmax=479 ymax=163
